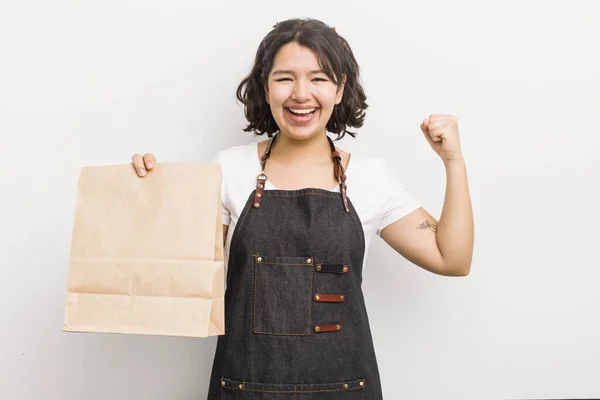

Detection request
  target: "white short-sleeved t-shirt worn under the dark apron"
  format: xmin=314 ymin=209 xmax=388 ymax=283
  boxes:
xmin=213 ymin=142 xmax=421 ymax=276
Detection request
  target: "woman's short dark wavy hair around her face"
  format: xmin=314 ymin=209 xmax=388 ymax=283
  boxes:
xmin=236 ymin=19 xmax=368 ymax=139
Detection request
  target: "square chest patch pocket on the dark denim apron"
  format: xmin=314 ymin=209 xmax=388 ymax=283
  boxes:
xmin=252 ymin=255 xmax=315 ymax=336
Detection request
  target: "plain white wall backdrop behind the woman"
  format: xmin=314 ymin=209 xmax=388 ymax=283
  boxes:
xmin=0 ymin=0 xmax=600 ymax=400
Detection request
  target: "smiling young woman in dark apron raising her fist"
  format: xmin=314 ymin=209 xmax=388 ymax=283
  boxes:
xmin=133 ymin=19 xmax=473 ymax=400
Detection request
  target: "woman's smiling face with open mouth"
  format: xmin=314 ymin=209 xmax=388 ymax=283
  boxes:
xmin=265 ymin=42 xmax=344 ymax=140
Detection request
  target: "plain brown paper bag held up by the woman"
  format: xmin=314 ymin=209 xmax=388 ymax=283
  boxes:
xmin=63 ymin=163 xmax=225 ymax=337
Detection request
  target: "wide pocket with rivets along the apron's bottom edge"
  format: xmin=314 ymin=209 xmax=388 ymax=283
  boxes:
xmin=221 ymin=378 xmax=366 ymax=400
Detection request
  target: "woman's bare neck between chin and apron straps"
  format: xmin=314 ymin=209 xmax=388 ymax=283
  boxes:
xmin=271 ymin=133 xmax=331 ymax=162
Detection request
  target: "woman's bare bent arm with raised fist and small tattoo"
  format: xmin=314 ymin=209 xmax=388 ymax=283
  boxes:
xmin=381 ymin=114 xmax=474 ymax=276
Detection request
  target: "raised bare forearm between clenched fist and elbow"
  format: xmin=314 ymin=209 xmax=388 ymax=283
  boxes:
xmin=436 ymin=160 xmax=474 ymax=274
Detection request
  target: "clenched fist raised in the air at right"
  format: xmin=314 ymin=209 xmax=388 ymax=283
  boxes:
xmin=421 ymin=114 xmax=463 ymax=163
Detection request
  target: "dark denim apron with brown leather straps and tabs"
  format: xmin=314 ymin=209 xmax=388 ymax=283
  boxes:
xmin=208 ymin=136 xmax=383 ymax=400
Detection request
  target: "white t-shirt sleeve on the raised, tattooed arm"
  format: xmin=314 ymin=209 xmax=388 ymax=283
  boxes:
xmin=377 ymin=162 xmax=421 ymax=236
